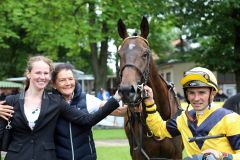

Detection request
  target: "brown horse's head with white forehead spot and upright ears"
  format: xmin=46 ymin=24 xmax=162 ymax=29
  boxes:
xmin=118 ymin=17 xmax=150 ymax=104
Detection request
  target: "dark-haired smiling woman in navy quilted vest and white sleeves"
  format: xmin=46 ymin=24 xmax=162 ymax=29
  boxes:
xmin=52 ymin=63 xmax=126 ymax=160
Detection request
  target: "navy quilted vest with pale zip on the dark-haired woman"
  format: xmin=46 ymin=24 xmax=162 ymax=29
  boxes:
xmin=53 ymin=83 xmax=97 ymax=160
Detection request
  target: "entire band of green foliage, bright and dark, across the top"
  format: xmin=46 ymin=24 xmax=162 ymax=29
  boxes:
xmin=7 ymin=0 xmax=240 ymax=90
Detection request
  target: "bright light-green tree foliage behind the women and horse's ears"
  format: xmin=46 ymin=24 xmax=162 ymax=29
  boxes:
xmin=0 ymin=0 xmax=176 ymax=91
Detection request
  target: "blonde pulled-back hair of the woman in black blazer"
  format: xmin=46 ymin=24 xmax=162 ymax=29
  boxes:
xmin=24 ymin=55 xmax=54 ymax=91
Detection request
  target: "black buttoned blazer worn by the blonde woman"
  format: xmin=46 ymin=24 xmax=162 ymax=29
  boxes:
xmin=0 ymin=92 xmax=119 ymax=160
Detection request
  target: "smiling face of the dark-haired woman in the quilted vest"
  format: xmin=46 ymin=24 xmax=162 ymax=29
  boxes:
xmin=53 ymin=69 xmax=76 ymax=100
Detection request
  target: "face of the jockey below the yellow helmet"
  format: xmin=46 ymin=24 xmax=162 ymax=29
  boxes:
xmin=187 ymin=87 xmax=215 ymax=111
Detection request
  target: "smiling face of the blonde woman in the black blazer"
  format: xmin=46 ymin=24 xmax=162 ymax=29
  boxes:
xmin=27 ymin=61 xmax=51 ymax=90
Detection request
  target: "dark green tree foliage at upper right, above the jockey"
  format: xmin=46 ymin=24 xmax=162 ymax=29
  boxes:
xmin=168 ymin=0 xmax=240 ymax=92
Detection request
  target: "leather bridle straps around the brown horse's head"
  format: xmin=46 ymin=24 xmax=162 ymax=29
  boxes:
xmin=119 ymin=36 xmax=151 ymax=105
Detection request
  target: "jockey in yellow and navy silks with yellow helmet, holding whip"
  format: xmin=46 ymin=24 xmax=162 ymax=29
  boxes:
xmin=144 ymin=67 xmax=240 ymax=160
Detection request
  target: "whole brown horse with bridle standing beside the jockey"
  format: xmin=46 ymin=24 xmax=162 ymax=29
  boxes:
xmin=118 ymin=17 xmax=183 ymax=160
